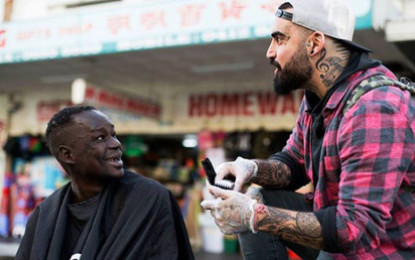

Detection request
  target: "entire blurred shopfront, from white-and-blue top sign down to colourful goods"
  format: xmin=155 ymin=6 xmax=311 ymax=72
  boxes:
xmin=0 ymin=0 xmax=412 ymax=254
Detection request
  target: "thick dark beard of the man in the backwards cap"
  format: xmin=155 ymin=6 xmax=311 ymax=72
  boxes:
xmin=274 ymin=48 xmax=312 ymax=95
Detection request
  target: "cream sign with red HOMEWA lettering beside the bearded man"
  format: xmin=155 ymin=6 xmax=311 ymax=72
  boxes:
xmin=173 ymin=90 xmax=302 ymax=132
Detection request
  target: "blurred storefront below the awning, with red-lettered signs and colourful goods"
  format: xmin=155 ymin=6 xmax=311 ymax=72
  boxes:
xmin=0 ymin=79 xmax=302 ymax=250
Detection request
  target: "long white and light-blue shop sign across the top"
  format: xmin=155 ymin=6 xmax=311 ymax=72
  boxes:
xmin=0 ymin=0 xmax=372 ymax=64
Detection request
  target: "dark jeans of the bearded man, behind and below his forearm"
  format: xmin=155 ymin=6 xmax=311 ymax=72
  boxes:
xmin=238 ymin=189 xmax=319 ymax=260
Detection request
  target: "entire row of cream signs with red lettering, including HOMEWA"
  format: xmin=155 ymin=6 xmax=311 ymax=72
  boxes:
xmin=10 ymin=86 xmax=303 ymax=136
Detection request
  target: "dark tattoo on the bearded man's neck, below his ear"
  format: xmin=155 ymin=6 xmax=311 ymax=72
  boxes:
xmin=316 ymin=48 xmax=348 ymax=88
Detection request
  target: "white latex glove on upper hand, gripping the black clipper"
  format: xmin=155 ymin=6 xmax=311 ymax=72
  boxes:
xmin=215 ymin=157 xmax=258 ymax=191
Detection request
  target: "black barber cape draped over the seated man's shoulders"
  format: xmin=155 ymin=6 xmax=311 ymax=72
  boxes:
xmin=15 ymin=171 xmax=194 ymax=260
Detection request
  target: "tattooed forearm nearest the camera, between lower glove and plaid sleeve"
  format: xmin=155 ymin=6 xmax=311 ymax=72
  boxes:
xmin=256 ymin=204 xmax=323 ymax=249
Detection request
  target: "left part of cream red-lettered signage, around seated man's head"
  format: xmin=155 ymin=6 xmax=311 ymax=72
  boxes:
xmin=10 ymin=87 xmax=162 ymax=136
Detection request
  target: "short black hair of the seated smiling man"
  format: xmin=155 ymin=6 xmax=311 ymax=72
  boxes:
xmin=45 ymin=106 xmax=96 ymax=145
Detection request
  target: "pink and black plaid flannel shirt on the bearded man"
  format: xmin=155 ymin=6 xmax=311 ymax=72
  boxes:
xmin=281 ymin=66 xmax=415 ymax=259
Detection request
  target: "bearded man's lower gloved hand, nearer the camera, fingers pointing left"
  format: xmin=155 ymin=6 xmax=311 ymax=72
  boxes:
xmin=201 ymin=186 xmax=257 ymax=235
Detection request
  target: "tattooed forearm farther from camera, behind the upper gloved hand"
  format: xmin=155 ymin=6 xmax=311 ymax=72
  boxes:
xmin=252 ymin=160 xmax=291 ymax=188
